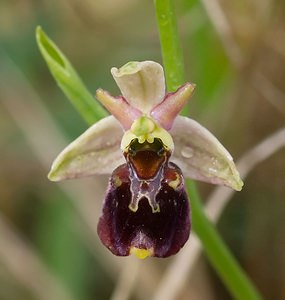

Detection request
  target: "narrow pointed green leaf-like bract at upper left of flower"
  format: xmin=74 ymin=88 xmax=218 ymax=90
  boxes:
xmin=36 ymin=26 xmax=107 ymax=124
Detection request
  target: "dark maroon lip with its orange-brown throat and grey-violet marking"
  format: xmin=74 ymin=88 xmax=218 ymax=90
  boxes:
xmin=98 ymin=139 xmax=191 ymax=257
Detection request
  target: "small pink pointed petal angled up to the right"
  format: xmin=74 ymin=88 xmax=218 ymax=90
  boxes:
xmin=150 ymin=82 xmax=196 ymax=130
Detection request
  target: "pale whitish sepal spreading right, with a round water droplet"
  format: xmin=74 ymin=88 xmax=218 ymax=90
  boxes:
xmin=170 ymin=116 xmax=243 ymax=191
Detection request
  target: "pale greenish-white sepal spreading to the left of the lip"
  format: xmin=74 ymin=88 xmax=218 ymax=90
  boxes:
xmin=48 ymin=116 xmax=124 ymax=181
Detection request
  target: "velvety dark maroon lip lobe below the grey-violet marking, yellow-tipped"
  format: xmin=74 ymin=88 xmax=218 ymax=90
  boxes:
xmin=98 ymin=163 xmax=190 ymax=258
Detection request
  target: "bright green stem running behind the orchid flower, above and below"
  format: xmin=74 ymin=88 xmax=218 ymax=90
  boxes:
xmin=154 ymin=0 xmax=261 ymax=300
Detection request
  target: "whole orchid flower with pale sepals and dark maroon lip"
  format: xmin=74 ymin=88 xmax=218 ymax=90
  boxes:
xmin=49 ymin=61 xmax=243 ymax=258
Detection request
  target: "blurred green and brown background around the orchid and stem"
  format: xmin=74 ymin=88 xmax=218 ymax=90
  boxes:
xmin=0 ymin=0 xmax=285 ymax=300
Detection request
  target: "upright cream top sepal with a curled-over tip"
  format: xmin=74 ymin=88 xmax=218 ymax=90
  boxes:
xmin=111 ymin=61 xmax=165 ymax=113
